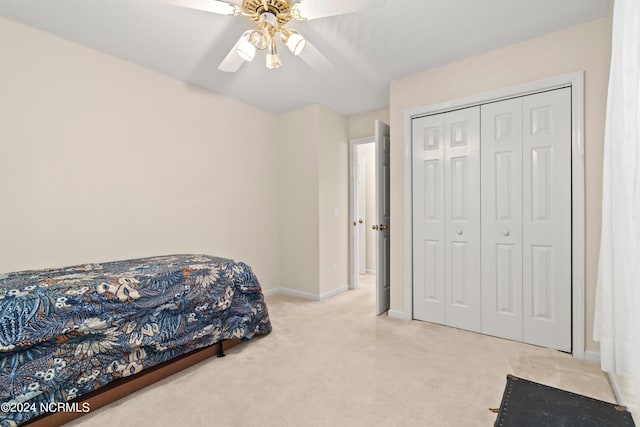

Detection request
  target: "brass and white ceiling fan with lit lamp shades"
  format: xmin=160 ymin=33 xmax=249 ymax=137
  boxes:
xmin=169 ymin=0 xmax=379 ymax=73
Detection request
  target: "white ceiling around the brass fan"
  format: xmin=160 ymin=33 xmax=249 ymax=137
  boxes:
xmin=0 ymin=0 xmax=610 ymax=115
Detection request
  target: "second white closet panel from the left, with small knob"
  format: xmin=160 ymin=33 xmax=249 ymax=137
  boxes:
xmin=444 ymin=107 xmax=481 ymax=332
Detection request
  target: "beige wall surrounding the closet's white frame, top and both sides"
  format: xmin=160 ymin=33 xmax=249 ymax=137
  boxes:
xmin=390 ymin=17 xmax=611 ymax=351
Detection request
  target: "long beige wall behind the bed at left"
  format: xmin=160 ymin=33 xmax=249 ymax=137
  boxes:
xmin=0 ymin=18 xmax=280 ymax=289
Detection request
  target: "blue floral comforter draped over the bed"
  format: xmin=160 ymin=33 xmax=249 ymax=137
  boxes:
xmin=0 ymin=255 xmax=271 ymax=427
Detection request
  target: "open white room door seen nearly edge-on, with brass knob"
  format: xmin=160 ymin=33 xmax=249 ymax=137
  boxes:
xmin=374 ymin=120 xmax=391 ymax=314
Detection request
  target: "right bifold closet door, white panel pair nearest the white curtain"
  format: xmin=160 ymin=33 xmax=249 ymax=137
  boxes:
xmin=481 ymin=88 xmax=571 ymax=351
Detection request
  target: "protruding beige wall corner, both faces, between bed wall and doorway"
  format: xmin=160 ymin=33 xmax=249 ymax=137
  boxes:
xmin=276 ymin=104 xmax=348 ymax=298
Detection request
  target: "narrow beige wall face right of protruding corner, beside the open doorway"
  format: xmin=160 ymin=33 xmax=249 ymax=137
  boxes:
xmin=318 ymin=106 xmax=349 ymax=295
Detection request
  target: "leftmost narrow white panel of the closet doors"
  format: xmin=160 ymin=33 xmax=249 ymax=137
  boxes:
xmin=412 ymin=114 xmax=445 ymax=324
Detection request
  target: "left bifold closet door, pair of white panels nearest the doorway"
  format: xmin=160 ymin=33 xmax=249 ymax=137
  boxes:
xmin=413 ymin=107 xmax=481 ymax=332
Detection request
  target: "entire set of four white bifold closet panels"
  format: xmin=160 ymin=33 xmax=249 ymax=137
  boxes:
xmin=412 ymin=88 xmax=571 ymax=351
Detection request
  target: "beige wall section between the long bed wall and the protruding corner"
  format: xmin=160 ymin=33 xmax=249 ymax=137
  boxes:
xmin=277 ymin=105 xmax=320 ymax=295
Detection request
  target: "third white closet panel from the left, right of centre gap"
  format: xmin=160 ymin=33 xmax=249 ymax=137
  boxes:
xmin=480 ymin=98 xmax=523 ymax=341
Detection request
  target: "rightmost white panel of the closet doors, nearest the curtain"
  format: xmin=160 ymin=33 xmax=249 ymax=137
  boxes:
xmin=522 ymin=88 xmax=571 ymax=351
